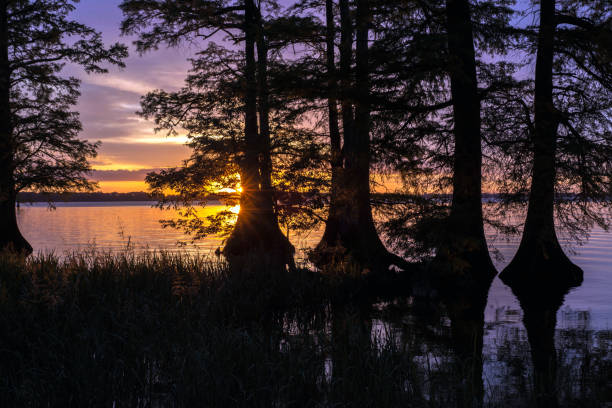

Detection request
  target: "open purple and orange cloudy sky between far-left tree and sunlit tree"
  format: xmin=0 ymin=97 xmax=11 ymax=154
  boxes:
xmin=65 ymin=0 xmax=194 ymax=192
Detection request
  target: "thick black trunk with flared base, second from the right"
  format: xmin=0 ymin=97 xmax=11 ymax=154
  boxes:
xmin=434 ymin=0 xmax=495 ymax=276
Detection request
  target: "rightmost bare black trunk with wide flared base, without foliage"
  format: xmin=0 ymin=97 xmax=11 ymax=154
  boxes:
xmin=500 ymin=0 xmax=582 ymax=283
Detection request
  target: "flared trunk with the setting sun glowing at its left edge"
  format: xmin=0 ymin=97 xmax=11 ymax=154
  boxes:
xmin=223 ymin=0 xmax=295 ymax=269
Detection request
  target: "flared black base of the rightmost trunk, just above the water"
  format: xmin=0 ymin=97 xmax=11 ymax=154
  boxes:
xmin=499 ymin=243 xmax=584 ymax=287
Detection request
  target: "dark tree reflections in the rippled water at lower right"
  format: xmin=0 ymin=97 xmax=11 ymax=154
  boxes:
xmin=310 ymin=270 xmax=612 ymax=408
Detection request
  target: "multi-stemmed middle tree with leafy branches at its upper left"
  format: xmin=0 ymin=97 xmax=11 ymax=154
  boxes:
xmin=288 ymin=1 xmax=406 ymax=270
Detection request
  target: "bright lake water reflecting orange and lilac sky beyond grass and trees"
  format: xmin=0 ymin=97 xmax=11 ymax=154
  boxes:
xmin=18 ymin=202 xmax=612 ymax=329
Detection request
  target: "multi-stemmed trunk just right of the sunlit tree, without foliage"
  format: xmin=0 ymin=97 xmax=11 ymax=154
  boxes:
xmin=313 ymin=0 xmax=406 ymax=271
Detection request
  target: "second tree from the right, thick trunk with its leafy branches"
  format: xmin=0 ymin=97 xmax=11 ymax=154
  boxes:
xmin=376 ymin=1 xmax=514 ymax=274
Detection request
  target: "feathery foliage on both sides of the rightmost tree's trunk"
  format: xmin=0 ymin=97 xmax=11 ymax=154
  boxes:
xmin=484 ymin=1 xmax=612 ymax=240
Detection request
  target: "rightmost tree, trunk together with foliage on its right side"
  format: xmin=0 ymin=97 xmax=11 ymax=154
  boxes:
xmin=502 ymin=0 xmax=612 ymax=282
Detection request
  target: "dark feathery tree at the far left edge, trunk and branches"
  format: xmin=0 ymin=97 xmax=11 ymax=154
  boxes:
xmin=0 ymin=0 xmax=127 ymax=252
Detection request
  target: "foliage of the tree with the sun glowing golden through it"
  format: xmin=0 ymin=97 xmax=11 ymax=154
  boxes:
xmin=122 ymin=1 xmax=328 ymax=262
